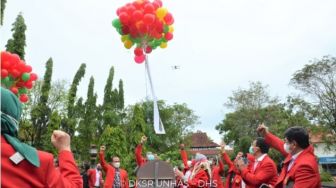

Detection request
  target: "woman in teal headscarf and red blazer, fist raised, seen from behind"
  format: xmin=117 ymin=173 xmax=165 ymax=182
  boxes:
xmin=1 ymin=87 xmax=83 ymax=188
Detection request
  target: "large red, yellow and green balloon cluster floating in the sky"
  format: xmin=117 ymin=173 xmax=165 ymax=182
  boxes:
xmin=112 ymin=0 xmax=174 ymax=63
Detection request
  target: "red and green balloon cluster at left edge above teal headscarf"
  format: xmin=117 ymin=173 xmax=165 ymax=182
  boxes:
xmin=1 ymin=51 xmax=37 ymax=103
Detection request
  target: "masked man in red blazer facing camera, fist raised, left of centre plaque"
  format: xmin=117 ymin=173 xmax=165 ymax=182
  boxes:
xmin=99 ymin=146 xmax=129 ymax=188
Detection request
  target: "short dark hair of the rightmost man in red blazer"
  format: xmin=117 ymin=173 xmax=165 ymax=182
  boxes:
xmin=285 ymin=126 xmax=309 ymax=149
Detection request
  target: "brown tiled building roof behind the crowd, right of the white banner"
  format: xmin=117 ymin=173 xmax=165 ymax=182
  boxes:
xmin=191 ymin=131 xmax=220 ymax=148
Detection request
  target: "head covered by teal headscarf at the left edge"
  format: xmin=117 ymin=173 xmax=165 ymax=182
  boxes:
xmin=1 ymin=87 xmax=22 ymax=137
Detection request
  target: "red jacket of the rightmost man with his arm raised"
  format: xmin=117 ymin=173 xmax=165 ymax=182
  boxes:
xmin=265 ymin=133 xmax=321 ymax=188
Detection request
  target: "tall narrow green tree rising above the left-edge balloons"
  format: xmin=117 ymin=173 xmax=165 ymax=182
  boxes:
xmin=6 ymin=13 xmax=27 ymax=60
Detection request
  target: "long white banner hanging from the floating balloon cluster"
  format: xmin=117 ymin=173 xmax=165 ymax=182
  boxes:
xmin=145 ymin=55 xmax=166 ymax=134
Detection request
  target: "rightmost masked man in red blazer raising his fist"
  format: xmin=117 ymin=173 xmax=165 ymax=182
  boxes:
xmin=257 ymin=124 xmax=321 ymax=188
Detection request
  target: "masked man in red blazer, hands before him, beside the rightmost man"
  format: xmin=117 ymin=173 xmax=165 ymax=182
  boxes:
xmin=237 ymin=137 xmax=278 ymax=188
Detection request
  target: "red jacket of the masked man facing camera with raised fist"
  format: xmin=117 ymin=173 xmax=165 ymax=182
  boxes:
xmin=99 ymin=152 xmax=129 ymax=188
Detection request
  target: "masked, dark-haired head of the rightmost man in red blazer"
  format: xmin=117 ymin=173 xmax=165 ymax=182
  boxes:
xmin=284 ymin=126 xmax=309 ymax=155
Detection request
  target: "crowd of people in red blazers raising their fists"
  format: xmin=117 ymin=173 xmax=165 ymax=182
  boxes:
xmin=1 ymin=88 xmax=321 ymax=188
